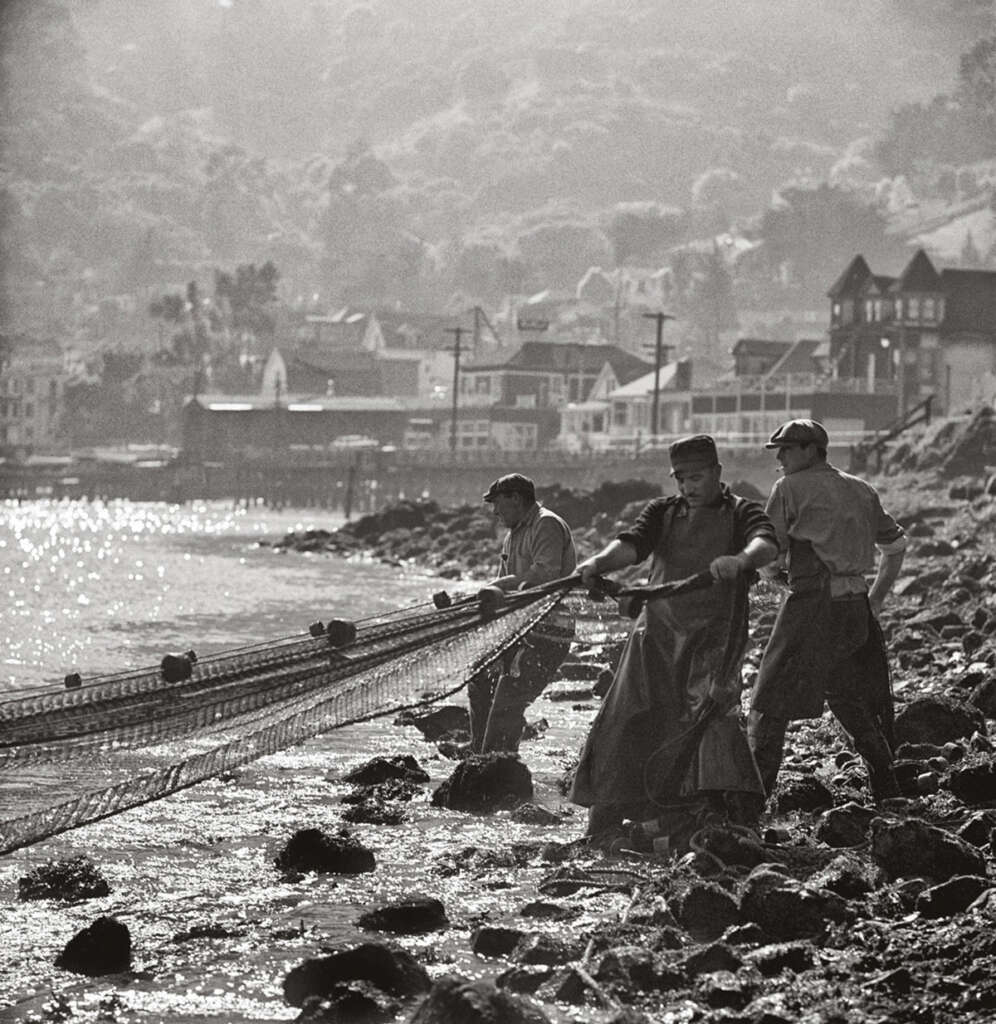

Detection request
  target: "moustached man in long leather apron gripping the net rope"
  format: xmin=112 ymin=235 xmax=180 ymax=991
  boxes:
xmin=570 ymin=434 xmax=778 ymax=848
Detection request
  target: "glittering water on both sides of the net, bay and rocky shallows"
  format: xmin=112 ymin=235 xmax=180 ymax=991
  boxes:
xmin=0 ymin=502 xmax=597 ymax=1022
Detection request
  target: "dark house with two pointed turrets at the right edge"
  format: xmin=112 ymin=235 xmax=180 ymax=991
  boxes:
xmin=828 ymin=249 xmax=996 ymax=415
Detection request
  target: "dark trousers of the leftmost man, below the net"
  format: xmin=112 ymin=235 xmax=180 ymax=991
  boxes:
xmin=467 ymin=635 xmax=570 ymax=754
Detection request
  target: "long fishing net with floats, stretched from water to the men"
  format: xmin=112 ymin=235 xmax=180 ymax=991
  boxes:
xmin=0 ymin=582 xmax=567 ymax=853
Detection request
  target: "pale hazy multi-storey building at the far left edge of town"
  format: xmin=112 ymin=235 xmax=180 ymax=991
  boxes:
xmin=0 ymin=338 xmax=68 ymax=453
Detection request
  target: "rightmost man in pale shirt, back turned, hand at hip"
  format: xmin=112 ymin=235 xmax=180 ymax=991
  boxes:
xmin=749 ymin=420 xmax=906 ymax=800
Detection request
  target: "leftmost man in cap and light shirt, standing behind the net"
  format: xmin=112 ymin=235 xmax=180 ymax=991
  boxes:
xmin=467 ymin=473 xmax=577 ymax=754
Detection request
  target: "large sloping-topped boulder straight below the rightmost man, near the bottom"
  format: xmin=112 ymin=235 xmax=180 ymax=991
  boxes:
xmin=740 ymin=865 xmax=850 ymax=941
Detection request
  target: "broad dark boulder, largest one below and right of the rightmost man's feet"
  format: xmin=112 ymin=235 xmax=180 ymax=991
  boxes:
xmin=870 ymin=818 xmax=986 ymax=882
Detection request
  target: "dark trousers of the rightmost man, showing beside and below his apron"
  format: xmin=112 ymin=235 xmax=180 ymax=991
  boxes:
xmin=747 ymin=595 xmax=899 ymax=800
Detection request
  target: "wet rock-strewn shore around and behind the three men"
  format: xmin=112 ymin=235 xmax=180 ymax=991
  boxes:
xmin=11 ymin=415 xmax=996 ymax=1024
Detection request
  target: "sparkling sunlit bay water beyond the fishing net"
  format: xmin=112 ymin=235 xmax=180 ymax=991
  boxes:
xmin=0 ymin=501 xmax=431 ymax=690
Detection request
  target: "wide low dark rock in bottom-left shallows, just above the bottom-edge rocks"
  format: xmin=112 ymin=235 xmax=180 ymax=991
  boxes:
xmin=284 ymin=942 xmax=432 ymax=1007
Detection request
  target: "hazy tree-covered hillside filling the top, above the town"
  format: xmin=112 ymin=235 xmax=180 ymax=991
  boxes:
xmin=0 ymin=0 xmax=996 ymax=331
